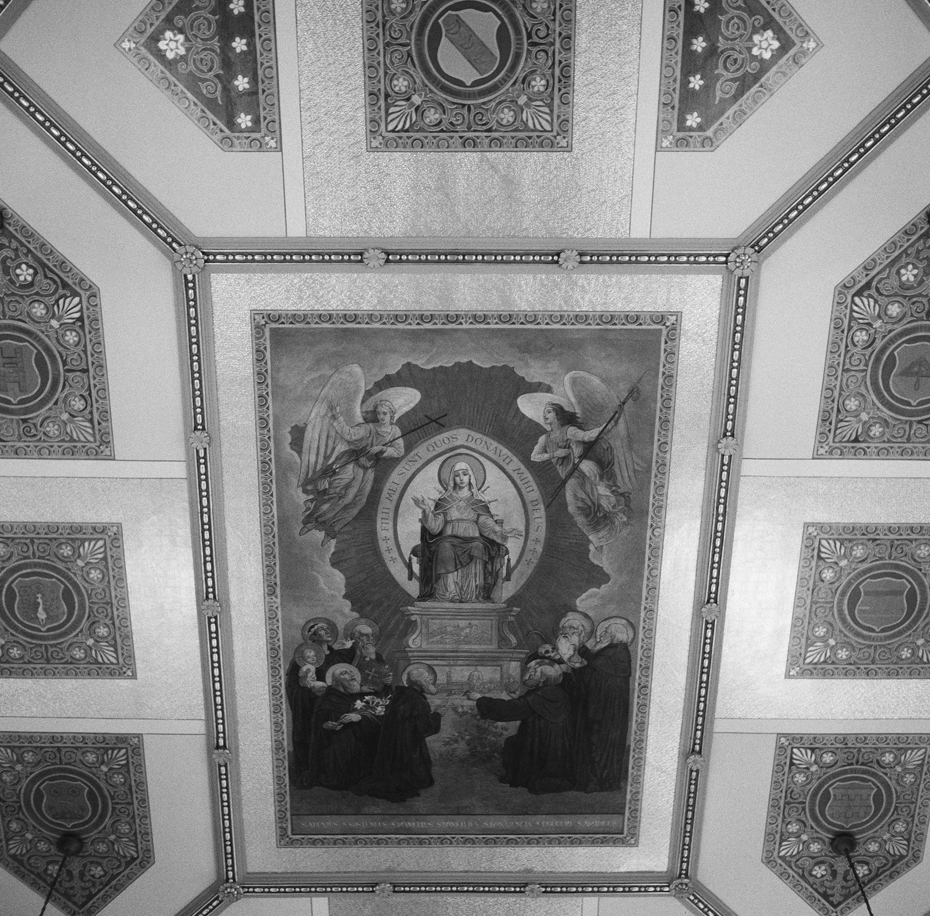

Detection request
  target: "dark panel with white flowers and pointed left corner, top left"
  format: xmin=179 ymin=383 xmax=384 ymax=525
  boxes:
xmin=117 ymin=0 xmax=281 ymax=152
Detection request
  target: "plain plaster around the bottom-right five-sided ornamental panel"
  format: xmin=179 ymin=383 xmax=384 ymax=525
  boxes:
xmin=697 ymin=736 xmax=930 ymax=916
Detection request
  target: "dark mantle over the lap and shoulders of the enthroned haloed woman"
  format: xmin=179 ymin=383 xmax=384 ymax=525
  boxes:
xmin=416 ymin=493 xmax=509 ymax=601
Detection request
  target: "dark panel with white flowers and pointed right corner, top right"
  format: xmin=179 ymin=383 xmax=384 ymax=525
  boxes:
xmin=658 ymin=0 xmax=820 ymax=150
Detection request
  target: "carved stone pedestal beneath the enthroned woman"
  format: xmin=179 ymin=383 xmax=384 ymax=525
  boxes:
xmin=398 ymin=601 xmax=526 ymax=696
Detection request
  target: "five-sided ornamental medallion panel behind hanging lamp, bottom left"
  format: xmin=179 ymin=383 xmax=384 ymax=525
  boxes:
xmin=0 ymin=732 xmax=155 ymax=916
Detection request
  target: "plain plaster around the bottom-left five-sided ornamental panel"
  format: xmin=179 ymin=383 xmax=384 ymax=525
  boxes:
xmin=0 ymin=734 xmax=214 ymax=914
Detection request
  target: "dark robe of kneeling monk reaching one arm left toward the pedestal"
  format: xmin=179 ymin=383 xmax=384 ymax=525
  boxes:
xmin=476 ymin=684 xmax=575 ymax=795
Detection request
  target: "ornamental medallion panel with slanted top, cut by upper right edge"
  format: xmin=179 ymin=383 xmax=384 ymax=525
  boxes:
xmin=815 ymin=213 xmax=930 ymax=458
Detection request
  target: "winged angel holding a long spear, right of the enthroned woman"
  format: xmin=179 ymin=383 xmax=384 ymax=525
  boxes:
xmin=517 ymin=372 xmax=639 ymax=550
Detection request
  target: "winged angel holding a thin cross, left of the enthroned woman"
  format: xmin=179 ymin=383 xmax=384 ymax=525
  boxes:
xmin=297 ymin=363 xmax=420 ymax=547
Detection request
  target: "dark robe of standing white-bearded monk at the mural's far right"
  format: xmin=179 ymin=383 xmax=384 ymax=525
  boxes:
xmin=568 ymin=643 xmax=632 ymax=792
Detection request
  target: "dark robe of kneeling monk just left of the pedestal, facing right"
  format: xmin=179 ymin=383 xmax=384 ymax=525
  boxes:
xmin=352 ymin=686 xmax=442 ymax=801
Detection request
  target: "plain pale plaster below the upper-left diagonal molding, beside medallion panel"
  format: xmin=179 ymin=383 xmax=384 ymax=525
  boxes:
xmin=0 ymin=104 xmax=186 ymax=473
